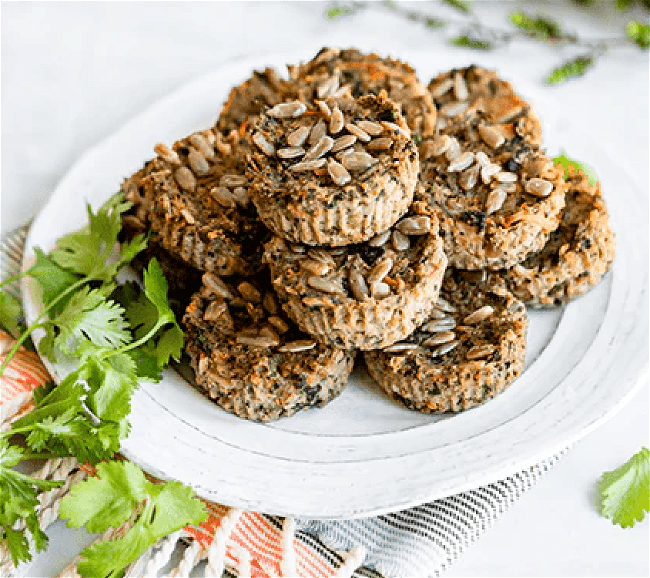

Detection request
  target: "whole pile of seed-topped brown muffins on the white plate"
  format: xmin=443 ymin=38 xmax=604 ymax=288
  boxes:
xmin=122 ymin=49 xmax=614 ymax=421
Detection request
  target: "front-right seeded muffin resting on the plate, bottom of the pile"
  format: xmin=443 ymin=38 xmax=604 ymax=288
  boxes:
xmin=364 ymin=269 xmax=528 ymax=413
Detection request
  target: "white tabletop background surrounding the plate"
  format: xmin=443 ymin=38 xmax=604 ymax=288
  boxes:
xmin=1 ymin=0 xmax=650 ymax=576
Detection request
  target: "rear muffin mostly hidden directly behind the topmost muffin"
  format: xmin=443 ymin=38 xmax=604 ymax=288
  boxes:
xmin=289 ymin=48 xmax=436 ymax=138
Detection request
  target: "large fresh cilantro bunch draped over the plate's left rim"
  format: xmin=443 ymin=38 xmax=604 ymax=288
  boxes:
xmin=0 ymin=195 xmax=190 ymax=576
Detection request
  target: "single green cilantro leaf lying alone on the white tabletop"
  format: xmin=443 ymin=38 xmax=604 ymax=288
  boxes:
xmin=598 ymin=447 xmax=650 ymax=528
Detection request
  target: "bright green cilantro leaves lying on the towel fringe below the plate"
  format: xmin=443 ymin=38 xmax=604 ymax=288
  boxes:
xmin=59 ymin=461 xmax=208 ymax=578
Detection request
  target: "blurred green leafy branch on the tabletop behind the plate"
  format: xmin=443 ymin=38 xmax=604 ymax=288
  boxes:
xmin=326 ymin=0 xmax=650 ymax=85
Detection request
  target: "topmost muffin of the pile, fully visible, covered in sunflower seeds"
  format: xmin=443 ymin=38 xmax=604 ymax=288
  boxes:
xmin=247 ymin=96 xmax=419 ymax=246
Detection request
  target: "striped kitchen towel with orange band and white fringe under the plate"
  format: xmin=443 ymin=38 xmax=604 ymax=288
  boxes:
xmin=0 ymin=226 xmax=560 ymax=578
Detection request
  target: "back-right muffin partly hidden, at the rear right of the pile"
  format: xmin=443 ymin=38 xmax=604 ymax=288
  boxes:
xmin=428 ymin=66 xmax=542 ymax=146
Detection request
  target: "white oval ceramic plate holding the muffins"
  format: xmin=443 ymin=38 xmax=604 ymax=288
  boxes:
xmin=23 ymin=53 xmax=648 ymax=518
